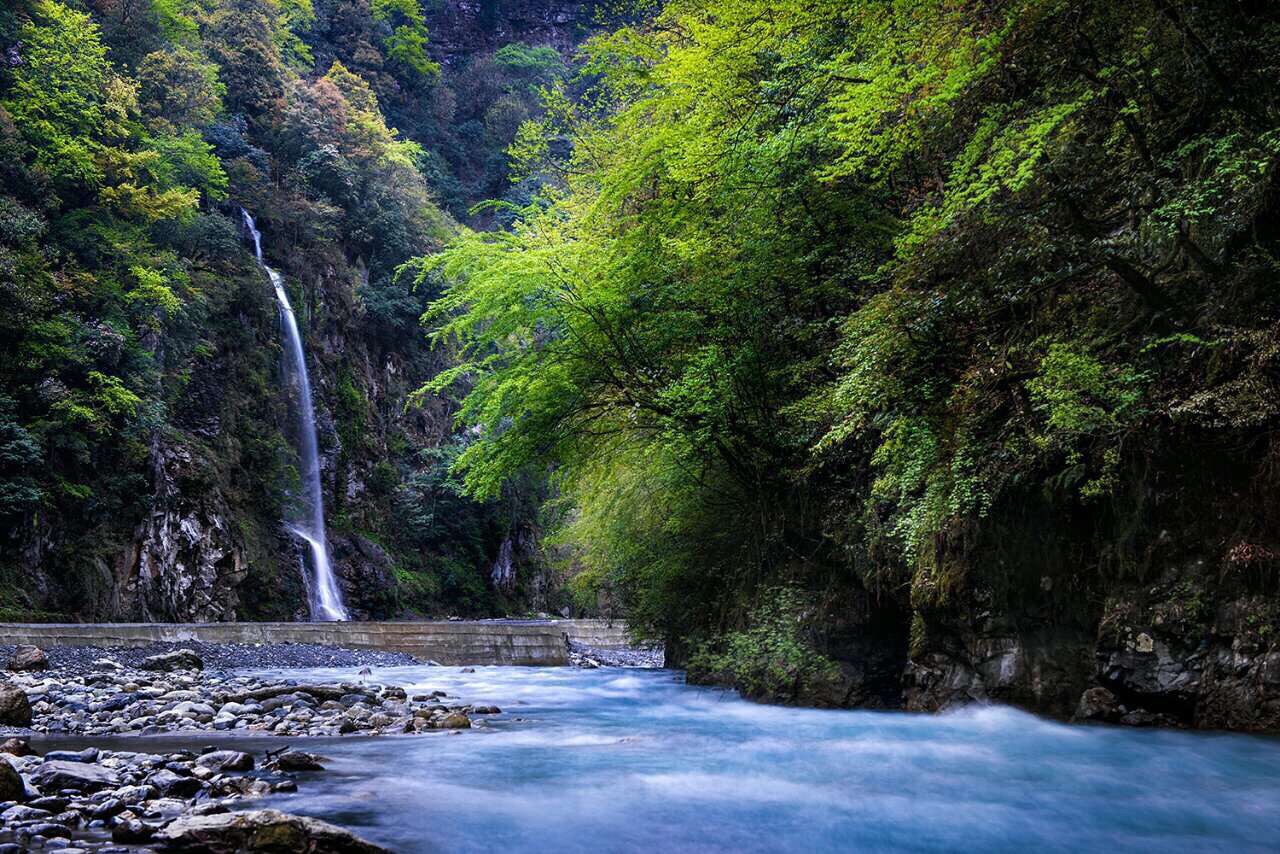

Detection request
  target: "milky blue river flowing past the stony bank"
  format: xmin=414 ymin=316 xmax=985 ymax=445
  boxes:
xmin=227 ymin=667 xmax=1280 ymax=853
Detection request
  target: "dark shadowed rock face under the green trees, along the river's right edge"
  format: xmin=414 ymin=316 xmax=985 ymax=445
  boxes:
xmin=711 ymin=456 xmax=1280 ymax=732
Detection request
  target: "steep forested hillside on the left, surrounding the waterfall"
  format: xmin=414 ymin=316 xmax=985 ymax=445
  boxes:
xmin=0 ymin=0 xmax=589 ymax=620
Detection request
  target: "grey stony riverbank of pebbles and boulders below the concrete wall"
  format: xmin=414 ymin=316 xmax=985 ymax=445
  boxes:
xmin=0 ymin=644 xmax=500 ymax=854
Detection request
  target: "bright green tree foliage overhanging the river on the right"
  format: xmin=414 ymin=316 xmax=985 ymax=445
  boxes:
xmin=424 ymin=0 xmax=1280 ymax=665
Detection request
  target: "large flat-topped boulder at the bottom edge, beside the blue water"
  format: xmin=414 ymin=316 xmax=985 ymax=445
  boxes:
xmin=155 ymin=809 xmax=388 ymax=854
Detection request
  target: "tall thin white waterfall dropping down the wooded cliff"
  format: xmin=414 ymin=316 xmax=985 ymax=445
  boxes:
xmin=241 ymin=209 xmax=347 ymax=620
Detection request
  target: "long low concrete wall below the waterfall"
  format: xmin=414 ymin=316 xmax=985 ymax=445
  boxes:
xmin=0 ymin=620 xmax=626 ymax=666
